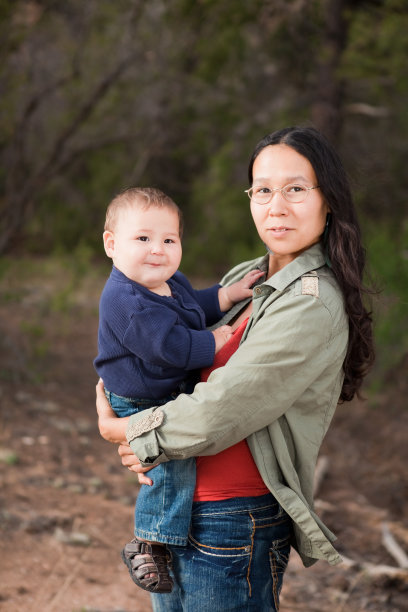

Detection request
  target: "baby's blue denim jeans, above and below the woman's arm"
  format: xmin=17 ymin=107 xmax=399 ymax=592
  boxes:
xmin=105 ymin=387 xmax=196 ymax=546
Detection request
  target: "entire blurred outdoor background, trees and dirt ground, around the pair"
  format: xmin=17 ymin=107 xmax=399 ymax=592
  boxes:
xmin=0 ymin=0 xmax=408 ymax=612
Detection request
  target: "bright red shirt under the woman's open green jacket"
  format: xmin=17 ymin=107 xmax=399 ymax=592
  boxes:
xmin=194 ymin=319 xmax=269 ymax=501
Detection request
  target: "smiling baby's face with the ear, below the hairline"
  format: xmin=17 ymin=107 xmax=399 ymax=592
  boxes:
xmin=104 ymin=205 xmax=182 ymax=294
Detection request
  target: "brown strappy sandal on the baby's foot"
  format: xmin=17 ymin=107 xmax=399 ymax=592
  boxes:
xmin=121 ymin=540 xmax=173 ymax=593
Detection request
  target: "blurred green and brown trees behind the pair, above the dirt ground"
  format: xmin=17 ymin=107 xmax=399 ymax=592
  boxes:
xmin=0 ymin=0 xmax=408 ymax=380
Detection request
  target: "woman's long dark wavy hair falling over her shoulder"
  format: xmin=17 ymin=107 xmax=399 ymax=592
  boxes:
xmin=248 ymin=127 xmax=374 ymax=401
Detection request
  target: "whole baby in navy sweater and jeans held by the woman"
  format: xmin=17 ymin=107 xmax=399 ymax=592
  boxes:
xmin=94 ymin=188 xmax=263 ymax=593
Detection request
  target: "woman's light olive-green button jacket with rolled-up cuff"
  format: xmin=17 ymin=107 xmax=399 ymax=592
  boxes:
xmin=127 ymin=245 xmax=348 ymax=566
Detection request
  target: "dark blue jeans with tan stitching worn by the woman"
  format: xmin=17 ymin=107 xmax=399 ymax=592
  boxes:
xmin=151 ymin=494 xmax=292 ymax=612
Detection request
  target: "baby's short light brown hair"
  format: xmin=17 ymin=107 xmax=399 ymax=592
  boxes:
xmin=104 ymin=187 xmax=183 ymax=238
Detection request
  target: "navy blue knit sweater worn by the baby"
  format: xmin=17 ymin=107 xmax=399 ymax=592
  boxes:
xmin=94 ymin=267 xmax=223 ymax=399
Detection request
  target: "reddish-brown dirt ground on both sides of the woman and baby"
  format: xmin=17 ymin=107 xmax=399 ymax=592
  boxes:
xmin=0 ymin=268 xmax=408 ymax=612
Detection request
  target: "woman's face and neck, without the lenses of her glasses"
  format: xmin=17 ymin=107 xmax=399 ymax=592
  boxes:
xmin=251 ymin=144 xmax=329 ymax=271
